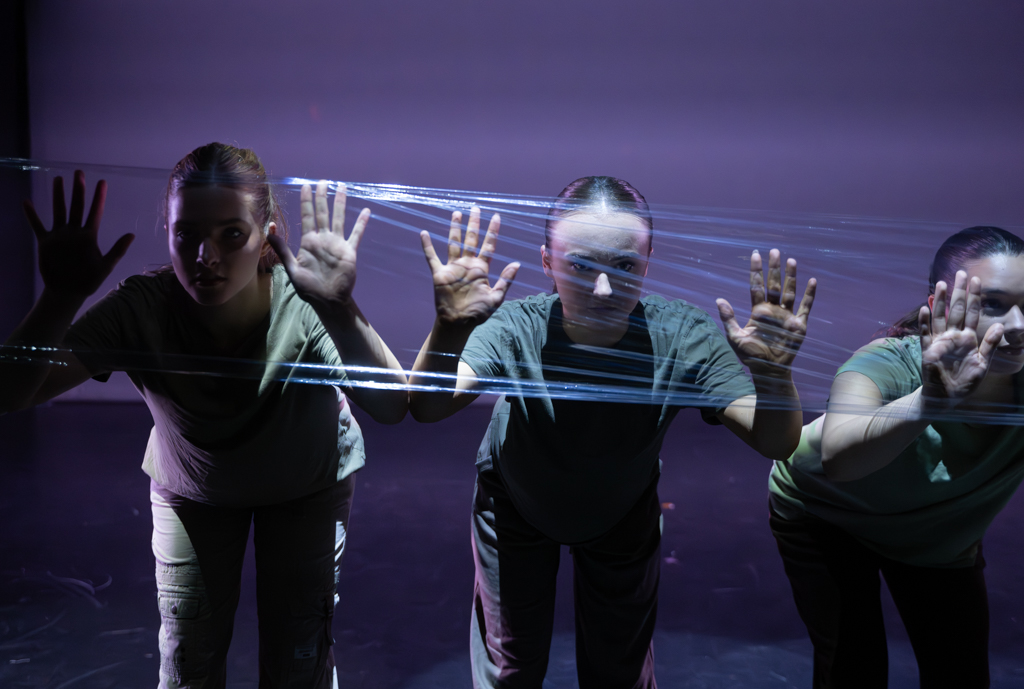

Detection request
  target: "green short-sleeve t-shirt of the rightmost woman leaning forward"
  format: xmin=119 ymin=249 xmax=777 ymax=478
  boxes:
xmin=769 ymin=337 xmax=1024 ymax=567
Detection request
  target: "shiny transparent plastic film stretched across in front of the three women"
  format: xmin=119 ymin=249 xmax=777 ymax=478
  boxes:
xmin=0 ymin=159 xmax=1024 ymax=425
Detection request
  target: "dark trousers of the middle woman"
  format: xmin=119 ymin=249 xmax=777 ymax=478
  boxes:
xmin=470 ymin=471 xmax=662 ymax=689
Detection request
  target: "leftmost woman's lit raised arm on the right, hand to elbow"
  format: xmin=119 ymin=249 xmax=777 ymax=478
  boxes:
xmin=267 ymin=180 xmax=409 ymax=424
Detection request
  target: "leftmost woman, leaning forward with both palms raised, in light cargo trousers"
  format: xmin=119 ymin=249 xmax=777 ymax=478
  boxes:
xmin=0 ymin=143 xmax=408 ymax=689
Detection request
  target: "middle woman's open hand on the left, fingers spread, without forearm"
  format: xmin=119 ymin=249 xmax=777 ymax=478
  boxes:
xmin=420 ymin=206 xmax=519 ymax=326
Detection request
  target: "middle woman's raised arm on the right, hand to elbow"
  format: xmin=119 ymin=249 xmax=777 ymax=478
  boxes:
xmin=717 ymin=249 xmax=817 ymax=460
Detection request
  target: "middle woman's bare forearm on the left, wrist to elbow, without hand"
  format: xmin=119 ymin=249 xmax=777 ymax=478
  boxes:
xmin=409 ymin=319 xmax=473 ymax=423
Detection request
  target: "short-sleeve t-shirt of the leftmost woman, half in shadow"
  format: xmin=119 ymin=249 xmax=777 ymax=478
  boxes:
xmin=65 ymin=265 xmax=366 ymax=506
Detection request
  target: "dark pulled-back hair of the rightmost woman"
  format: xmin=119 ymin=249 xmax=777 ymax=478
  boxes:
xmin=885 ymin=225 xmax=1024 ymax=338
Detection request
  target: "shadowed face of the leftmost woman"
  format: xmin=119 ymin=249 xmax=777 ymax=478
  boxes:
xmin=167 ymin=185 xmax=273 ymax=306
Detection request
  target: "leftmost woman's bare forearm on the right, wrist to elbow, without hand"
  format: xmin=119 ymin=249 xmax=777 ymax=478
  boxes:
xmin=313 ymin=301 xmax=409 ymax=424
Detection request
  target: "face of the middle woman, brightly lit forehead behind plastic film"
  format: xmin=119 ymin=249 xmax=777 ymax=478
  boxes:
xmin=541 ymin=210 xmax=650 ymax=336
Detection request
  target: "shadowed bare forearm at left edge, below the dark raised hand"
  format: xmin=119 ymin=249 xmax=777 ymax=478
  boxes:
xmin=0 ymin=290 xmax=85 ymax=413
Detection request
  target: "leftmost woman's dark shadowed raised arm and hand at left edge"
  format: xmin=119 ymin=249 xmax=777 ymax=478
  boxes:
xmin=0 ymin=170 xmax=135 ymax=413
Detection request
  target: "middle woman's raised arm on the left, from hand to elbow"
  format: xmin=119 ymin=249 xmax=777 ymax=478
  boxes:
xmin=410 ymin=206 xmax=519 ymax=423
